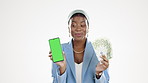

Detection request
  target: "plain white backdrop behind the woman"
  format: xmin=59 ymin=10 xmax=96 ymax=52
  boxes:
xmin=0 ymin=0 xmax=148 ymax=83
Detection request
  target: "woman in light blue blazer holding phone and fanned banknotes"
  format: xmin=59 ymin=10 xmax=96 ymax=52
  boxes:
xmin=49 ymin=10 xmax=109 ymax=83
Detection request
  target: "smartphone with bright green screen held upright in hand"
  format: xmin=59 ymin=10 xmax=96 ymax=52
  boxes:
xmin=48 ymin=38 xmax=64 ymax=62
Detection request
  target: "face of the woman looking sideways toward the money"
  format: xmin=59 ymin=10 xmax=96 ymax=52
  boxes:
xmin=69 ymin=16 xmax=88 ymax=40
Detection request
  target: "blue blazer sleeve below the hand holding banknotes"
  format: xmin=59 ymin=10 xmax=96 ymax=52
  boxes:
xmin=95 ymin=69 xmax=109 ymax=83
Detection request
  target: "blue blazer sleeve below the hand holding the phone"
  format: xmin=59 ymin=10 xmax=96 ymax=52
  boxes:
xmin=52 ymin=63 xmax=67 ymax=83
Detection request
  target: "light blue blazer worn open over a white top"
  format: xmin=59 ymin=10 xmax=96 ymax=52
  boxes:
xmin=52 ymin=40 xmax=109 ymax=83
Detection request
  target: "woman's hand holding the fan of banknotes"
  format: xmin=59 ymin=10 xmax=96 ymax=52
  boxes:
xmin=96 ymin=55 xmax=109 ymax=74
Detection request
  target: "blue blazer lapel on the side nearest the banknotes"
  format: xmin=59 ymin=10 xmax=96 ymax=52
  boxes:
xmin=82 ymin=40 xmax=93 ymax=80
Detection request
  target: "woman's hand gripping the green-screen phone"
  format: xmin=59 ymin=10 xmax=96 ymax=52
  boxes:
xmin=49 ymin=52 xmax=66 ymax=75
